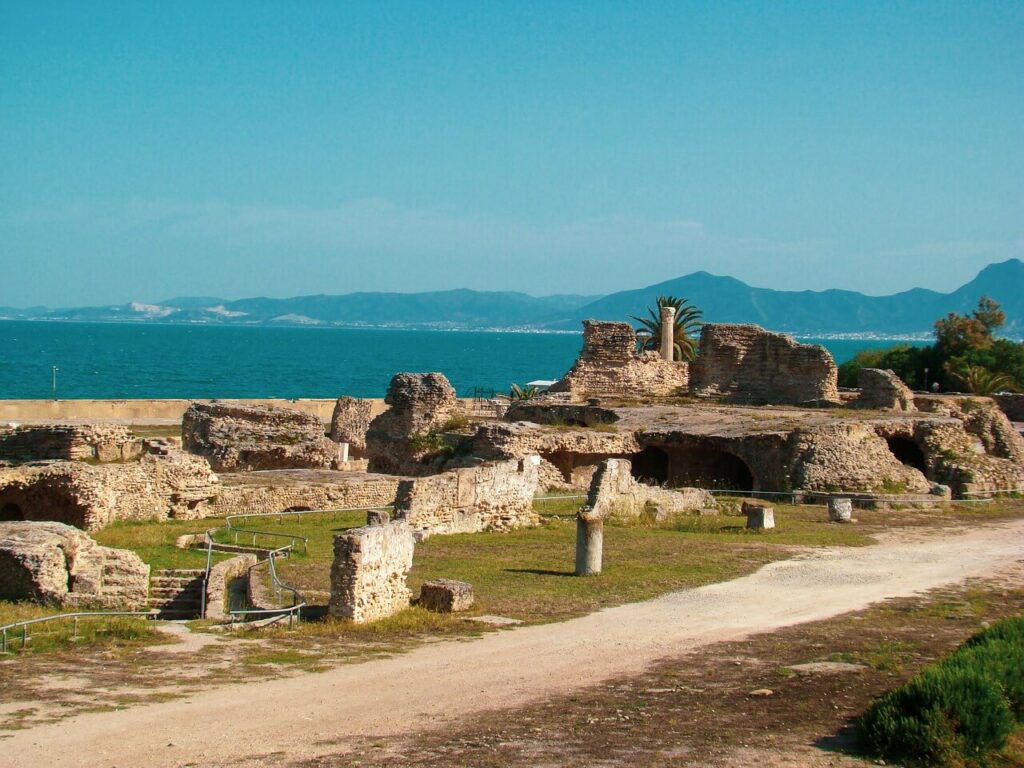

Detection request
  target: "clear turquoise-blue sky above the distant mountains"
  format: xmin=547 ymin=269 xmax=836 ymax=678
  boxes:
xmin=0 ymin=0 xmax=1024 ymax=307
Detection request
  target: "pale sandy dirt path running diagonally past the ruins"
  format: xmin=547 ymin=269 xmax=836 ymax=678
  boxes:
xmin=8 ymin=520 xmax=1024 ymax=768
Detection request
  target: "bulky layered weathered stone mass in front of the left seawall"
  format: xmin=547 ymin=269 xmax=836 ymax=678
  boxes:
xmin=181 ymin=401 xmax=338 ymax=472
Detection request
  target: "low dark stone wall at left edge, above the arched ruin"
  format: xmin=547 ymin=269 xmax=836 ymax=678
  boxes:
xmin=0 ymin=424 xmax=142 ymax=463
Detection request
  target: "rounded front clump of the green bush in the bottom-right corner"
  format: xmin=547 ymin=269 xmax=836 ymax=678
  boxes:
xmin=859 ymin=665 xmax=1014 ymax=765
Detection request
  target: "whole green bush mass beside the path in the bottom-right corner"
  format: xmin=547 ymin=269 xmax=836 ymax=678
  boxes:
xmin=858 ymin=617 xmax=1024 ymax=765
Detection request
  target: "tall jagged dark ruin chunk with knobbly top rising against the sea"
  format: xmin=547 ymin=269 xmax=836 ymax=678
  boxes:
xmin=367 ymin=373 xmax=461 ymax=475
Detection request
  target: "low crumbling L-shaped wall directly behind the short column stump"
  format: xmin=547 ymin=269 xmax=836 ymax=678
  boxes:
xmin=587 ymin=459 xmax=716 ymax=520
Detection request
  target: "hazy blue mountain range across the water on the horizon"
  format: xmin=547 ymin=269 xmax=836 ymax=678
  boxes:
xmin=0 ymin=259 xmax=1024 ymax=338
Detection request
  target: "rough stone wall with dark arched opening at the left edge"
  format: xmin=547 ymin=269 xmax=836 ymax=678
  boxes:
xmin=0 ymin=445 xmax=217 ymax=530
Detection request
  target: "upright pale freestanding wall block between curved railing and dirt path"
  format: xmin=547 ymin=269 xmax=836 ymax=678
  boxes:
xmin=328 ymin=520 xmax=415 ymax=624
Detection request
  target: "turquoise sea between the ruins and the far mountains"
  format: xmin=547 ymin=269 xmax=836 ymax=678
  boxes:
xmin=0 ymin=321 xmax=926 ymax=399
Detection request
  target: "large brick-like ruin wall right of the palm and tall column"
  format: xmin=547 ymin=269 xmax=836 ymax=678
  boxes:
xmin=690 ymin=323 xmax=840 ymax=403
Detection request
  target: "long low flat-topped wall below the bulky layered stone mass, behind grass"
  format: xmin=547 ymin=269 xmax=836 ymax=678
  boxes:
xmin=208 ymin=475 xmax=403 ymax=517
